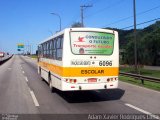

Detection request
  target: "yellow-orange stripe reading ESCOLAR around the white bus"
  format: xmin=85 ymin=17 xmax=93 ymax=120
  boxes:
xmin=38 ymin=62 xmax=119 ymax=77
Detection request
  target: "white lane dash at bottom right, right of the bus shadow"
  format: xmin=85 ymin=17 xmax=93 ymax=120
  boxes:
xmin=125 ymin=103 xmax=160 ymax=120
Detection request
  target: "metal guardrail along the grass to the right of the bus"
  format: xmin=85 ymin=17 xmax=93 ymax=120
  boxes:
xmin=120 ymin=72 xmax=160 ymax=84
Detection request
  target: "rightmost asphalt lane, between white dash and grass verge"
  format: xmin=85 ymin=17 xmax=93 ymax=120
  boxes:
xmin=119 ymin=82 xmax=160 ymax=114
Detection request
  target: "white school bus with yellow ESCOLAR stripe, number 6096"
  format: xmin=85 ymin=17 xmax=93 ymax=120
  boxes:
xmin=38 ymin=28 xmax=119 ymax=92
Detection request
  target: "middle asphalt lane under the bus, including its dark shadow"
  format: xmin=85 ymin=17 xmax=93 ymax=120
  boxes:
xmin=20 ymin=57 xmax=139 ymax=114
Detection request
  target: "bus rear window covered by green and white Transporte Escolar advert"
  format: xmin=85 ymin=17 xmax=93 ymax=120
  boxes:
xmin=70 ymin=31 xmax=115 ymax=55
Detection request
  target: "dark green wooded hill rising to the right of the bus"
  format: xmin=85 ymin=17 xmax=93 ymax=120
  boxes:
xmin=105 ymin=21 xmax=160 ymax=66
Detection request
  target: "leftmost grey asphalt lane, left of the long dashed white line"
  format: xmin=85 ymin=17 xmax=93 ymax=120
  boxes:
xmin=0 ymin=56 xmax=37 ymax=114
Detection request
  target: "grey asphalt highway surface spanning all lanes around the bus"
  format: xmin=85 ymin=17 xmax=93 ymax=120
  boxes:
xmin=0 ymin=55 xmax=160 ymax=120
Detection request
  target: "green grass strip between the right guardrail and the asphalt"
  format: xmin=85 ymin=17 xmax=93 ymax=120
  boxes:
xmin=119 ymin=76 xmax=160 ymax=91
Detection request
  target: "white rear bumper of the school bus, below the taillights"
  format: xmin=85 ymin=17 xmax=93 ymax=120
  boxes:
xmin=62 ymin=80 xmax=118 ymax=91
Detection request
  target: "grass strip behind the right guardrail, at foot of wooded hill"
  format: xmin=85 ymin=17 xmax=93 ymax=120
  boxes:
xmin=120 ymin=67 xmax=160 ymax=78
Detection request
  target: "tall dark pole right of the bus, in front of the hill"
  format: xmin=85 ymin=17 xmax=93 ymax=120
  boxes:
xmin=133 ymin=0 xmax=138 ymax=73
